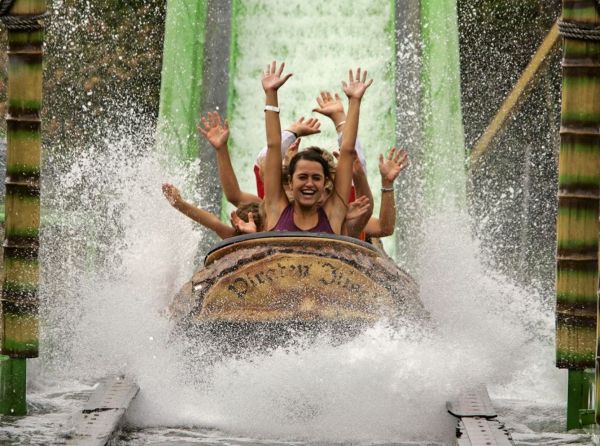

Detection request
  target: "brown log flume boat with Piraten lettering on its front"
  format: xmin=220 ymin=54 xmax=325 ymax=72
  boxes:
xmin=169 ymin=232 xmax=427 ymax=354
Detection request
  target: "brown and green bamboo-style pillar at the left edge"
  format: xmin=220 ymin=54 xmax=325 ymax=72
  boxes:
xmin=0 ymin=0 xmax=46 ymax=415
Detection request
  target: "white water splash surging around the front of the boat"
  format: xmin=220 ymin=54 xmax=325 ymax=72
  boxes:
xmin=30 ymin=123 xmax=563 ymax=442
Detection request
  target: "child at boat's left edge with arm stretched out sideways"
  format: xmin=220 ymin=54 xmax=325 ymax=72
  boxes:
xmin=162 ymin=183 xmax=263 ymax=239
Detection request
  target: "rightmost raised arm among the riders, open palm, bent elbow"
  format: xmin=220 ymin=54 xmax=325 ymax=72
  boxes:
xmin=365 ymin=148 xmax=410 ymax=237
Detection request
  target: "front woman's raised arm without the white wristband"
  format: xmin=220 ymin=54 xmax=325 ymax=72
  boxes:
xmin=325 ymin=68 xmax=373 ymax=231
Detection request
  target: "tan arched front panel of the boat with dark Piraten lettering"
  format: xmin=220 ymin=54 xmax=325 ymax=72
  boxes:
xmin=202 ymin=253 xmax=392 ymax=321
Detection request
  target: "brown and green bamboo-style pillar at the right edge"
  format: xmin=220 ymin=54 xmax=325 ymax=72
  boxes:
xmin=556 ymin=0 xmax=600 ymax=429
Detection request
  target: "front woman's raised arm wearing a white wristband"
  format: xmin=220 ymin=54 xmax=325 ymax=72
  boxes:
xmin=262 ymin=61 xmax=291 ymax=228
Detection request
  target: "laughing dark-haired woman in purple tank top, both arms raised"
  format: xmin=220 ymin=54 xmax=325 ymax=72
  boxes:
xmin=262 ymin=62 xmax=373 ymax=234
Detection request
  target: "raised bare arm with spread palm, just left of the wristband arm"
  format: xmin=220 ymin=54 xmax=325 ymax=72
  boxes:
xmin=198 ymin=112 xmax=261 ymax=206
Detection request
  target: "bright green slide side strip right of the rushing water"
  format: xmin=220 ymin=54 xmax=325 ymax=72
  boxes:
xmin=421 ymin=0 xmax=466 ymax=212
